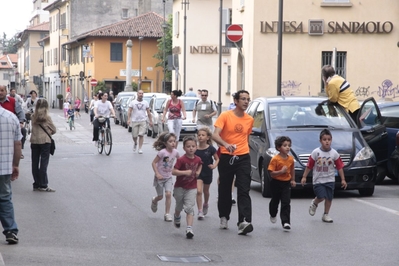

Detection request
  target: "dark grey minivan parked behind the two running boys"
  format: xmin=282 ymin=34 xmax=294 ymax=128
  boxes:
xmin=247 ymin=97 xmax=385 ymax=197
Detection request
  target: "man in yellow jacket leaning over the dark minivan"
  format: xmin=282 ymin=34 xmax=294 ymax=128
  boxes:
xmin=321 ymin=65 xmax=360 ymax=123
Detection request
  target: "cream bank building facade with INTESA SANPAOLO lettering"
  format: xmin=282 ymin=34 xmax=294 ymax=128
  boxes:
xmin=173 ymin=0 xmax=399 ymax=107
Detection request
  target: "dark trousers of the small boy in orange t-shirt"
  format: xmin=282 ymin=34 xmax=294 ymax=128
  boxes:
xmin=269 ymin=179 xmax=291 ymax=225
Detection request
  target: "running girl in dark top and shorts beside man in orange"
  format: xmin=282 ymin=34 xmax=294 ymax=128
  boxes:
xmin=195 ymin=127 xmax=219 ymax=220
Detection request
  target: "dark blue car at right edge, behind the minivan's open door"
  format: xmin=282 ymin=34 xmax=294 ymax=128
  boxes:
xmin=360 ymin=101 xmax=399 ymax=184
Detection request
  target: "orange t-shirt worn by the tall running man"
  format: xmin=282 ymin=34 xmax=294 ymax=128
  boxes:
xmin=215 ymin=110 xmax=254 ymax=155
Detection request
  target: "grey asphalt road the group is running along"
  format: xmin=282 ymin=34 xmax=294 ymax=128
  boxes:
xmin=0 ymin=109 xmax=399 ymax=266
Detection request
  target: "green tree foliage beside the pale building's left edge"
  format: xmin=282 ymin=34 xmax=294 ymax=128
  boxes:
xmin=154 ymin=15 xmax=173 ymax=81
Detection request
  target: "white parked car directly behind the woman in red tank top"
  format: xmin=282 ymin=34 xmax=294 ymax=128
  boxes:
xmin=162 ymin=97 xmax=198 ymax=138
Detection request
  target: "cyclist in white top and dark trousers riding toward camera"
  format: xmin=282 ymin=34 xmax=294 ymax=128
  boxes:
xmin=93 ymin=93 xmax=115 ymax=142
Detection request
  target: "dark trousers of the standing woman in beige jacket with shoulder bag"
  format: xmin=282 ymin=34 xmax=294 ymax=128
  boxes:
xmin=30 ymin=143 xmax=51 ymax=188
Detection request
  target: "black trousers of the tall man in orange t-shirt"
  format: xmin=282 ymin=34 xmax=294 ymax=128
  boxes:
xmin=218 ymin=154 xmax=252 ymax=224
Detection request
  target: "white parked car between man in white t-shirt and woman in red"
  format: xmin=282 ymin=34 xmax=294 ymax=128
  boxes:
xmin=147 ymin=93 xmax=169 ymax=138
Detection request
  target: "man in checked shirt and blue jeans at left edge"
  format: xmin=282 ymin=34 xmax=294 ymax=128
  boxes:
xmin=0 ymin=107 xmax=22 ymax=244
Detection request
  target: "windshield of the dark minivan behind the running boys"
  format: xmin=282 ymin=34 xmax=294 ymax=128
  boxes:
xmin=269 ymin=102 xmax=351 ymax=129
